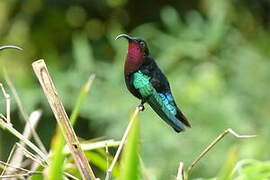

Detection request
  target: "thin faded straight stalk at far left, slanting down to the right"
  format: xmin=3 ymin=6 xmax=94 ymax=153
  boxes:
xmin=4 ymin=73 xmax=48 ymax=155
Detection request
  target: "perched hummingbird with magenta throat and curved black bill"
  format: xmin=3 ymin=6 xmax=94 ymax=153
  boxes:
xmin=116 ymin=34 xmax=191 ymax=132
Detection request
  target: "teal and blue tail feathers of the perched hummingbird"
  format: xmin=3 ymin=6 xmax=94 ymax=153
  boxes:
xmin=146 ymin=92 xmax=190 ymax=132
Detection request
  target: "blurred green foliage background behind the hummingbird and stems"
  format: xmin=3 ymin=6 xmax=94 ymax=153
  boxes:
xmin=0 ymin=0 xmax=270 ymax=179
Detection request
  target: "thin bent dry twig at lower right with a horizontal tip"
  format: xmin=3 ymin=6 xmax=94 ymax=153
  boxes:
xmin=187 ymin=128 xmax=256 ymax=175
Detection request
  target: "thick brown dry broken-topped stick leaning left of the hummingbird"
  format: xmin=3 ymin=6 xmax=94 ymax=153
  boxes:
xmin=32 ymin=60 xmax=96 ymax=180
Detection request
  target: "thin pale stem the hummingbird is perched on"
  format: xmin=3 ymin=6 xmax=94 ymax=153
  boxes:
xmin=105 ymin=106 xmax=142 ymax=180
